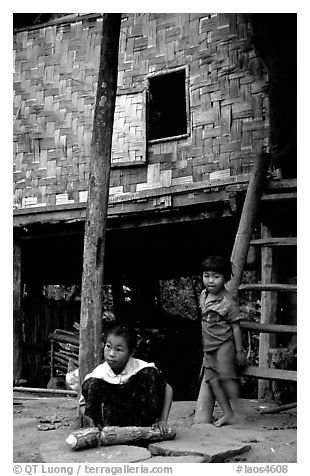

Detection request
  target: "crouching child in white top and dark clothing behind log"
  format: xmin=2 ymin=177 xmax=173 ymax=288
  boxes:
xmin=80 ymin=324 xmax=173 ymax=434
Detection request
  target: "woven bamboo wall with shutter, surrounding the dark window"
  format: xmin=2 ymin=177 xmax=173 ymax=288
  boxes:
xmin=13 ymin=13 xmax=269 ymax=208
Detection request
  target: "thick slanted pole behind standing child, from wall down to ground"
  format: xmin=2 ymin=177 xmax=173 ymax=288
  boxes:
xmin=194 ymin=153 xmax=270 ymax=423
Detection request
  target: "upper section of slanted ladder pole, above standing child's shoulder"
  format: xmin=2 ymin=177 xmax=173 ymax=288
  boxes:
xmin=227 ymin=153 xmax=270 ymax=298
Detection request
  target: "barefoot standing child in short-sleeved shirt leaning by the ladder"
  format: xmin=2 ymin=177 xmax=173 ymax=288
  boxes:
xmin=200 ymin=256 xmax=246 ymax=427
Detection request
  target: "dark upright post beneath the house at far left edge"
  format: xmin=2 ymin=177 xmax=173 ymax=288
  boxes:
xmin=13 ymin=239 xmax=23 ymax=381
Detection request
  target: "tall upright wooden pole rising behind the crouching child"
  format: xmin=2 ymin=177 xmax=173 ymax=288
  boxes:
xmin=79 ymin=13 xmax=121 ymax=382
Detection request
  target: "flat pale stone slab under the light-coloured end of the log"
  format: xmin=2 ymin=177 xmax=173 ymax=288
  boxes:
xmin=40 ymin=440 xmax=151 ymax=464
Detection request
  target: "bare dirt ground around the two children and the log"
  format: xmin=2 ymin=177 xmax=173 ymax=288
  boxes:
xmin=13 ymin=392 xmax=297 ymax=463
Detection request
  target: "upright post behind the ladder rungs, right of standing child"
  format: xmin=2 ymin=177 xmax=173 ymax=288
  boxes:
xmin=258 ymin=224 xmax=278 ymax=399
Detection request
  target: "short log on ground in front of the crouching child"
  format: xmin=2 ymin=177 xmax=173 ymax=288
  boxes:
xmin=66 ymin=426 xmax=176 ymax=450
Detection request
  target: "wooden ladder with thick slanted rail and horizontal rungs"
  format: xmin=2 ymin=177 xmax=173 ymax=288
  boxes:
xmin=194 ymin=153 xmax=297 ymax=423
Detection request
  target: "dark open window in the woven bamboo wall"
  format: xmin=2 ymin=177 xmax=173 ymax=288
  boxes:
xmin=148 ymin=69 xmax=187 ymax=140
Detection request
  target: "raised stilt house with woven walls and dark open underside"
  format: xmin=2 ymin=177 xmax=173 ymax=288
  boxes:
xmin=13 ymin=13 xmax=297 ymax=398
